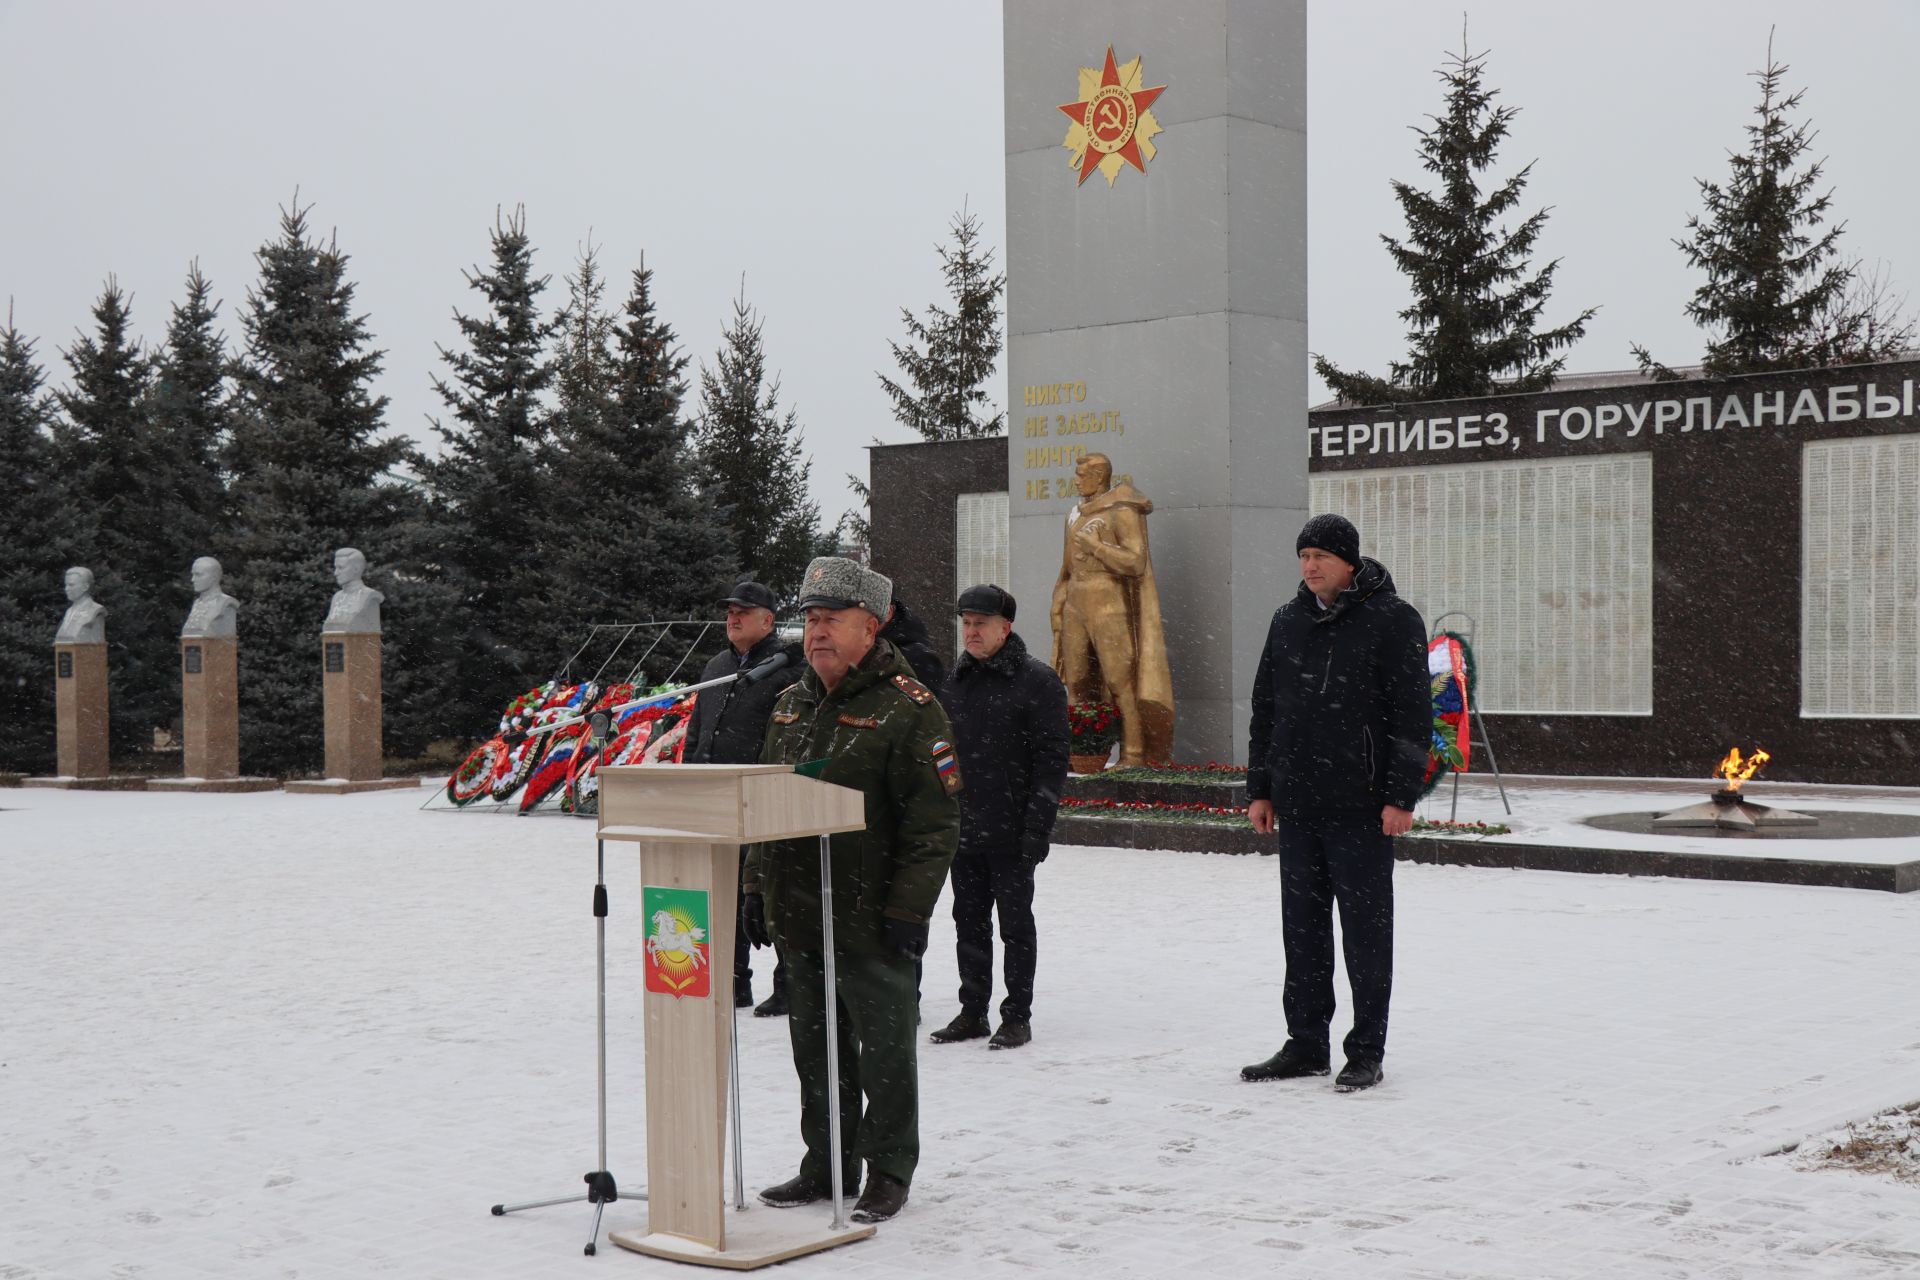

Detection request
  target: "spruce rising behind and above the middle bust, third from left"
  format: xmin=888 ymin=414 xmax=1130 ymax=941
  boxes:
xmin=146 ymin=261 xmax=230 ymax=564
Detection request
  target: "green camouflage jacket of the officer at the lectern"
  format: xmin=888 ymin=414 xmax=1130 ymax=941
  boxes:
xmin=741 ymin=641 xmax=960 ymax=954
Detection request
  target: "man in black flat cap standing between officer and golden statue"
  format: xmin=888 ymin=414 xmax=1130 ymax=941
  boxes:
xmin=933 ymin=585 xmax=1068 ymax=1050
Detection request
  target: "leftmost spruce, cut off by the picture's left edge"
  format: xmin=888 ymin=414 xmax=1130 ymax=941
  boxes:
xmin=0 ymin=312 xmax=75 ymax=773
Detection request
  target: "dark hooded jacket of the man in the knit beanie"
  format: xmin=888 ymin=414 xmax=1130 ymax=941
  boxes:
xmin=1246 ymin=557 xmax=1432 ymax=816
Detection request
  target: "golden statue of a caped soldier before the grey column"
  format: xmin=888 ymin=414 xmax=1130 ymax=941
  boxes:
xmin=1052 ymin=453 xmax=1173 ymax=764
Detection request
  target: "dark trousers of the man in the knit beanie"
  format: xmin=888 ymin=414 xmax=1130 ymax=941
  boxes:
xmin=1279 ymin=814 xmax=1394 ymax=1061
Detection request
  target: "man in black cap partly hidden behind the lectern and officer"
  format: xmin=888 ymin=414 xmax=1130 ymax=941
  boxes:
xmin=682 ymin=581 xmax=804 ymax=1017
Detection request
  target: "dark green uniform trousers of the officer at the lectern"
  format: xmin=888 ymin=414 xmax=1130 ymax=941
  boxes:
xmin=785 ymin=952 xmax=920 ymax=1186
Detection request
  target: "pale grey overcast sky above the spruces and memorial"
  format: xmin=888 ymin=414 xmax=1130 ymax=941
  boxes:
xmin=0 ymin=0 xmax=1920 ymax=520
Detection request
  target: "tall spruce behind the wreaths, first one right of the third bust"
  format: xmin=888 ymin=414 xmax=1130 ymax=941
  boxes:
xmin=424 ymin=209 xmax=555 ymax=723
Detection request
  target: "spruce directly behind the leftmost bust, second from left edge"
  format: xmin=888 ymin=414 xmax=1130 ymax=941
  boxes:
xmin=54 ymin=276 xmax=176 ymax=754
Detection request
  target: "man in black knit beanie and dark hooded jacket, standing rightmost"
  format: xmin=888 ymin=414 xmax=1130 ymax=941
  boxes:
xmin=1240 ymin=516 xmax=1432 ymax=1092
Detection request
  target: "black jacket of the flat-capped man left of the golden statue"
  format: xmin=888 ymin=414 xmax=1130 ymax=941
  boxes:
xmin=941 ymin=635 xmax=1069 ymax=862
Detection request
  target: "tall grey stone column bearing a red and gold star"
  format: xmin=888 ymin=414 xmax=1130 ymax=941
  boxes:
xmin=1004 ymin=0 xmax=1308 ymax=760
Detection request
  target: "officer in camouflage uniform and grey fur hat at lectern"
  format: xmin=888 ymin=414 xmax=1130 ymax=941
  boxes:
xmin=741 ymin=557 xmax=960 ymax=1222
